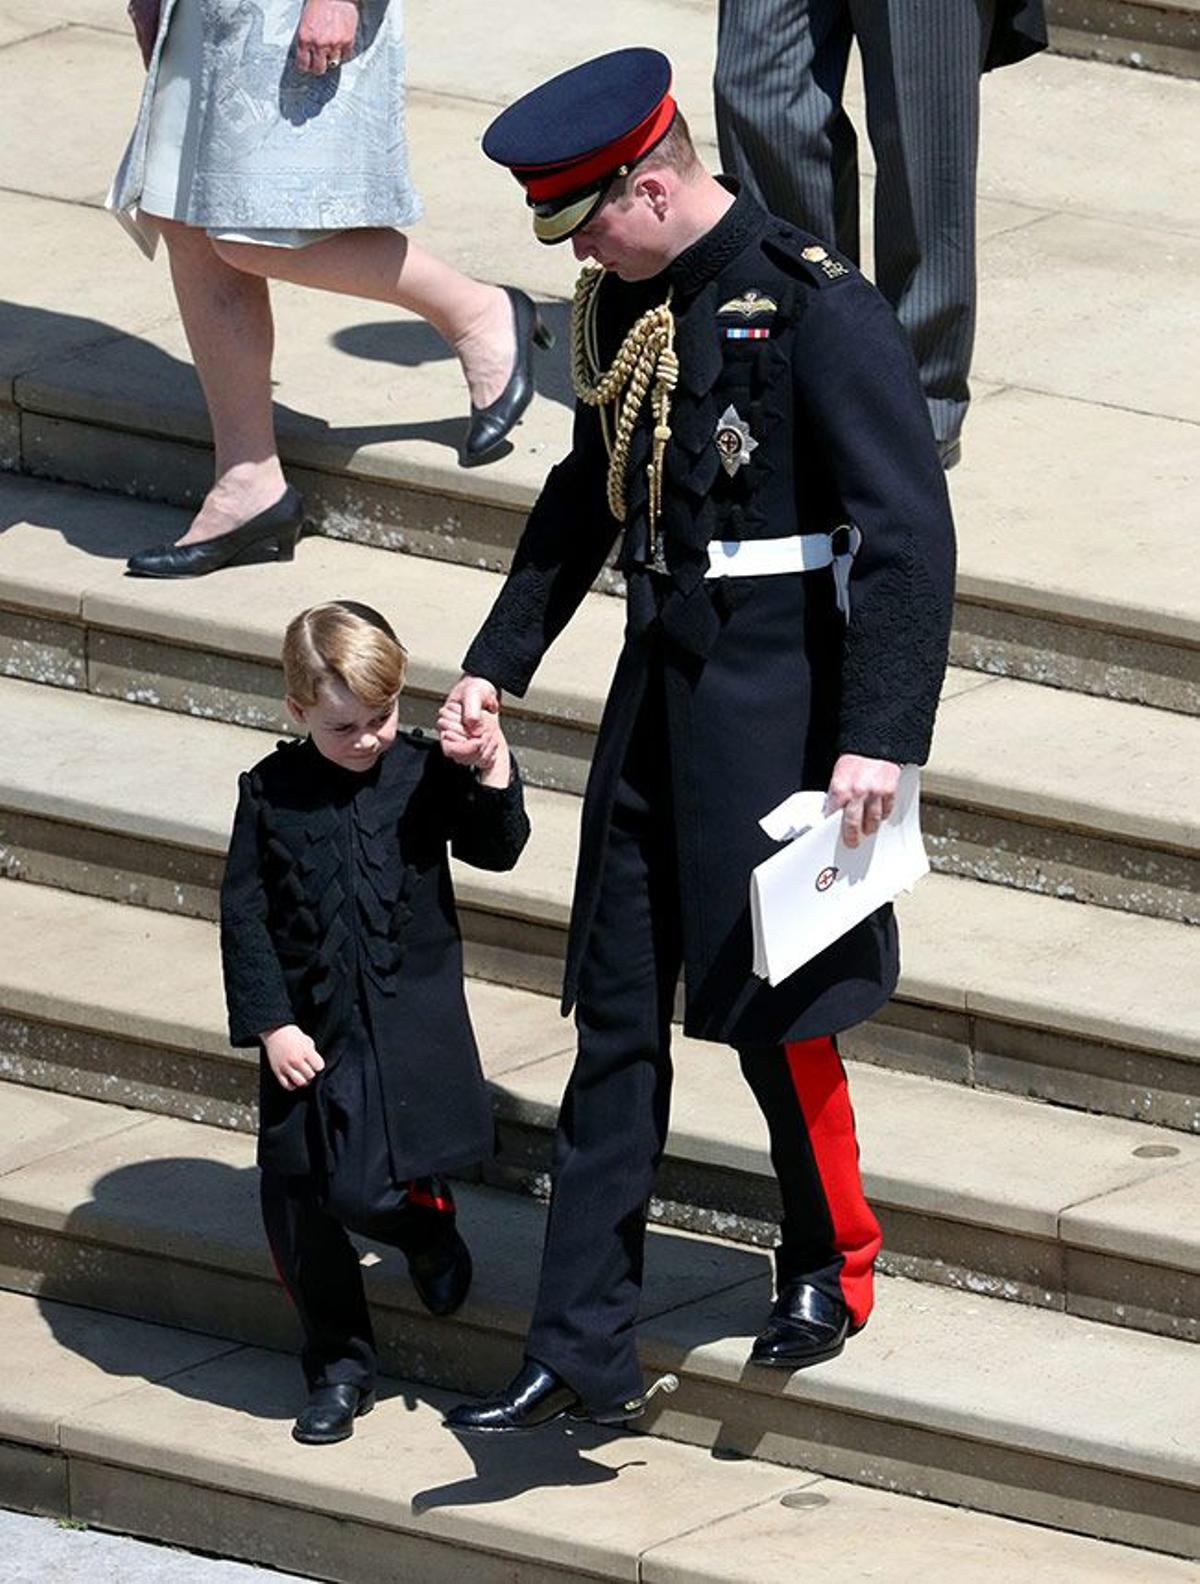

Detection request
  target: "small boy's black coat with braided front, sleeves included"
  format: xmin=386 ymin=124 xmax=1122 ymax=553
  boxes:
xmin=222 ymin=733 xmax=529 ymax=1199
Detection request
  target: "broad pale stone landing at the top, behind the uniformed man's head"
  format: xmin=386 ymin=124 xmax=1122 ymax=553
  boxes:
xmin=0 ymin=23 xmax=1200 ymax=711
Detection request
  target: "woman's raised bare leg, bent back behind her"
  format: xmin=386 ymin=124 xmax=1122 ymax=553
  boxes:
xmin=212 ymin=227 xmax=516 ymax=407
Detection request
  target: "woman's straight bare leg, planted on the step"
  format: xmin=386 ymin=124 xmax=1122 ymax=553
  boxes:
xmin=160 ymin=220 xmax=285 ymax=545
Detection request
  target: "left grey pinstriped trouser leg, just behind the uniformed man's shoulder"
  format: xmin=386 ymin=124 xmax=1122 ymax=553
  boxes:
xmin=712 ymin=0 xmax=858 ymax=258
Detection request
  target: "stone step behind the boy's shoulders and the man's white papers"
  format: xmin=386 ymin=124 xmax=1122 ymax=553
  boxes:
xmin=0 ymin=681 xmax=1200 ymax=1128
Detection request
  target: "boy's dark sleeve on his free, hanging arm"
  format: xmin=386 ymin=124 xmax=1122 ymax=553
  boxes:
xmin=220 ymin=775 xmax=296 ymax=1045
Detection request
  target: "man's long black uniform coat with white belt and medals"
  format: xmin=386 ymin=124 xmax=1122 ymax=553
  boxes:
xmin=464 ymin=193 xmax=955 ymax=1045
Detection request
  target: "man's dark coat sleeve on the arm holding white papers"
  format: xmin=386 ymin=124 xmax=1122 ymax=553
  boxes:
xmin=796 ymin=276 xmax=955 ymax=763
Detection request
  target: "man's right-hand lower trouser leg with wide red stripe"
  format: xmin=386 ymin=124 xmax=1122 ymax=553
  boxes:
xmin=738 ymin=1038 xmax=882 ymax=1327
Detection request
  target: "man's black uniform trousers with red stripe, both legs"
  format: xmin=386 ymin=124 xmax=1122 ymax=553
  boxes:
xmin=526 ymin=674 xmax=880 ymax=1408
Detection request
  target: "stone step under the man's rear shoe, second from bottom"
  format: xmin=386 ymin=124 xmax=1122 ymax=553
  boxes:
xmin=0 ymin=1090 xmax=1200 ymax=1555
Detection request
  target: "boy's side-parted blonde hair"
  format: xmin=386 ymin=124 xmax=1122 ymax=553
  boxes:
xmin=283 ymin=599 xmax=408 ymax=710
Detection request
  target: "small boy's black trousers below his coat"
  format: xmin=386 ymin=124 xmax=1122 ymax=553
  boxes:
xmin=260 ymin=1171 xmax=454 ymax=1391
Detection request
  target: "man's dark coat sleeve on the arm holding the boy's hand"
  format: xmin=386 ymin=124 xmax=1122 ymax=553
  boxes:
xmin=462 ymin=406 xmax=619 ymax=697
